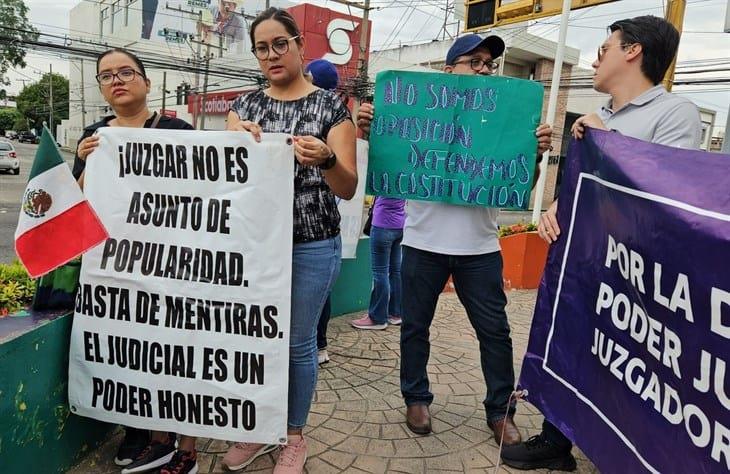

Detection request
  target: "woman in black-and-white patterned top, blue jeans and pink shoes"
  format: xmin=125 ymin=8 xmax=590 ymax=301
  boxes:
xmin=223 ymin=8 xmax=357 ymax=474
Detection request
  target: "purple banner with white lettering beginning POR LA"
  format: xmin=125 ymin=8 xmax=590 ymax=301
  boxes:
xmin=520 ymin=130 xmax=730 ymax=474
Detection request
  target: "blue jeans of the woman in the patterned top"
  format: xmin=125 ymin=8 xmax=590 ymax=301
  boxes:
xmin=288 ymin=235 xmax=342 ymax=428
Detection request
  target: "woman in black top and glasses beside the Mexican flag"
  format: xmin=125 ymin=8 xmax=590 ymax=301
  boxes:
xmin=73 ymin=48 xmax=198 ymax=474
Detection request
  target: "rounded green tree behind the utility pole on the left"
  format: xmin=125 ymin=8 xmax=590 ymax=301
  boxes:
xmin=15 ymin=73 xmax=68 ymax=130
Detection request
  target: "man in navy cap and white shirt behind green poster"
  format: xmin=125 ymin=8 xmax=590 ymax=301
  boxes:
xmin=358 ymin=34 xmax=552 ymax=445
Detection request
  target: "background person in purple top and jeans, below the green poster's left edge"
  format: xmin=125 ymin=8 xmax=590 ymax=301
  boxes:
xmin=350 ymin=193 xmax=406 ymax=329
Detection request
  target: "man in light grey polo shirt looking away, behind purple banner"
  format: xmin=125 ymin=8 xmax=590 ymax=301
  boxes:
xmin=502 ymin=16 xmax=702 ymax=471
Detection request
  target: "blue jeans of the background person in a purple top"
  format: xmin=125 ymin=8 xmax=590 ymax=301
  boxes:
xmin=368 ymin=226 xmax=403 ymax=324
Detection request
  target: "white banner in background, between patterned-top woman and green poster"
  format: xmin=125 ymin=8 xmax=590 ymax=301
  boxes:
xmin=337 ymin=138 xmax=368 ymax=258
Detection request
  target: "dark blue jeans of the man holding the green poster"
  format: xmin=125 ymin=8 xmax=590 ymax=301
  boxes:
xmin=400 ymin=246 xmax=515 ymax=420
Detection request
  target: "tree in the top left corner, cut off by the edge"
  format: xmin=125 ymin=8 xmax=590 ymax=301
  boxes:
xmin=0 ymin=0 xmax=38 ymax=92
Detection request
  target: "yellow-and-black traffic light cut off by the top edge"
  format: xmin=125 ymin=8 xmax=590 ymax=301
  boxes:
xmin=464 ymin=0 xmax=618 ymax=32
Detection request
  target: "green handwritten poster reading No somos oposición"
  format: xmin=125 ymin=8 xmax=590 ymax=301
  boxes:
xmin=366 ymin=71 xmax=543 ymax=209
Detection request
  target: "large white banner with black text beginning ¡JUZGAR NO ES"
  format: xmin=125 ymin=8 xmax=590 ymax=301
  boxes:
xmin=69 ymin=128 xmax=294 ymax=443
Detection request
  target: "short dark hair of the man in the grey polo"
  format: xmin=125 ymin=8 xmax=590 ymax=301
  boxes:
xmin=608 ymin=15 xmax=679 ymax=85
